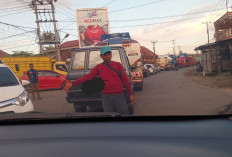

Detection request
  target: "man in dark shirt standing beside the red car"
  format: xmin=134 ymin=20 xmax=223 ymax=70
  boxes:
xmin=27 ymin=64 xmax=42 ymax=100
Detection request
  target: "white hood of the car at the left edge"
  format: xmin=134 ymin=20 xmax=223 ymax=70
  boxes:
xmin=0 ymin=85 xmax=24 ymax=102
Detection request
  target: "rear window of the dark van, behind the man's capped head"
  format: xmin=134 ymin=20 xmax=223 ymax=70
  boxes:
xmin=89 ymin=50 xmax=121 ymax=69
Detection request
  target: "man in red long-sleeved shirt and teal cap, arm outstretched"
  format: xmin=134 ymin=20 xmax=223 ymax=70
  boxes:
xmin=65 ymin=46 xmax=135 ymax=115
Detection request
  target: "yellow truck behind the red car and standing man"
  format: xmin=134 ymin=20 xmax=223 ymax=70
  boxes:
xmin=0 ymin=56 xmax=68 ymax=79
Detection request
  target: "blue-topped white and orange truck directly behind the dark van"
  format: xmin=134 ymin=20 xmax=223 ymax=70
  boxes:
xmin=100 ymin=32 xmax=143 ymax=91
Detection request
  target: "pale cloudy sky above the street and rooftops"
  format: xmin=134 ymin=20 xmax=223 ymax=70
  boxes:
xmin=0 ymin=0 xmax=232 ymax=55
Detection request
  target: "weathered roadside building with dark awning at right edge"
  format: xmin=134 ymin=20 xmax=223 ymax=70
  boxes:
xmin=195 ymin=12 xmax=232 ymax=73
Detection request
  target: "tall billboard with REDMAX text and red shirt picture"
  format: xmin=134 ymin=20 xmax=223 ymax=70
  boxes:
xmin=76 ymin=8 xmax=109 ymax=47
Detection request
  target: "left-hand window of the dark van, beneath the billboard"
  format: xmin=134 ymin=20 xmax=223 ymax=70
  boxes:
xmin=72 ymin=52 xmax=85 ymax=70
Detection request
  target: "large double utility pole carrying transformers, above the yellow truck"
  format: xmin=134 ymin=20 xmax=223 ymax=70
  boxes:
xmin=31 ymin=0 xmax=61 ymax=61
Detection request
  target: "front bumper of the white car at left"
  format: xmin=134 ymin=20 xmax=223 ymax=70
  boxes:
xmin=0 ymin=100 xmax=35 ymax=113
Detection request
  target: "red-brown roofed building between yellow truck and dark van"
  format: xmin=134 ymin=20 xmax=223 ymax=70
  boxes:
xmin=45 ymin=40 xmax=79 ymax=63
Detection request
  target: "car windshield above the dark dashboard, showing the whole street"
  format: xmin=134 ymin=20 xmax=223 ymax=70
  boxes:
xmin=0 ymin=0 xmax=232 ymax=116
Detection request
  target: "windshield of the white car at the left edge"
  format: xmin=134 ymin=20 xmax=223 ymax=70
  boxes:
xmin=0 ymin=67 xmax=19 ymax=87
